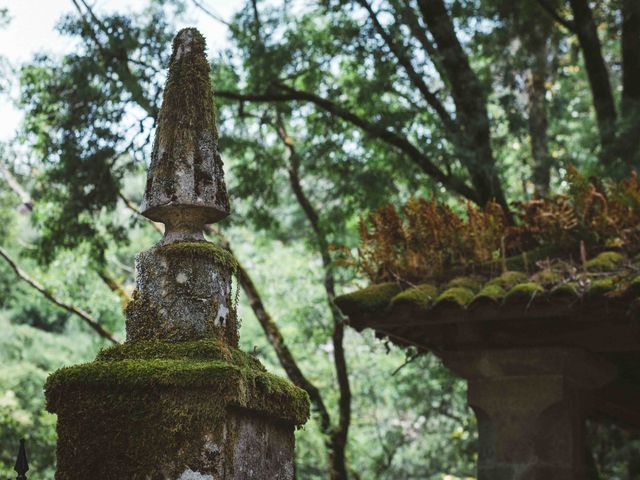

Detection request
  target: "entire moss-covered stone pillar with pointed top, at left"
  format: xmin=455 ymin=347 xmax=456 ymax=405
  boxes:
xmin=45 ymin=29 xmax=309 ymax=480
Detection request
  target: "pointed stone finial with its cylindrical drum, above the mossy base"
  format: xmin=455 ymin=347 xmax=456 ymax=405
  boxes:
xmin=126 ymin=28 xmax=238 ymax=346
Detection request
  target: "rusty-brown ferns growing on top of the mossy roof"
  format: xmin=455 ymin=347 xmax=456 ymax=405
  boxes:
xmin=352 ymin=167 xmax=640 ymax=283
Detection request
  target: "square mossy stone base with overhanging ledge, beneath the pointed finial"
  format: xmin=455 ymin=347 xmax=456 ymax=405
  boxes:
xmin=46 ymin=341 xmax=309 ymax=480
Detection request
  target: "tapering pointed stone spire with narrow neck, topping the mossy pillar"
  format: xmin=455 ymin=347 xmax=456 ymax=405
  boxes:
xmin=141 ymin=28 xmax=229 ymax=243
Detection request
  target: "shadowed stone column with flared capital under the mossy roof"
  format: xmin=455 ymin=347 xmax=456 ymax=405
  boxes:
xmin=443 ymin=348 xmax=615 ymax=480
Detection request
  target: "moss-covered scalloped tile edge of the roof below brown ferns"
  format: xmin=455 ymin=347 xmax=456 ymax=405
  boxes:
xmin=335 ymin=251 xmax=640 ymax=316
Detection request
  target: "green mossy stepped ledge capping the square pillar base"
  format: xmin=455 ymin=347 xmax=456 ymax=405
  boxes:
xmin=45 ymin=340 xmax=309 ymax=425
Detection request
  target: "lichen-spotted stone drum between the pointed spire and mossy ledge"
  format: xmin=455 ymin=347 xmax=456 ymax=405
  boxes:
xmin=126 ymin=241 xmax=238 ymax=346
